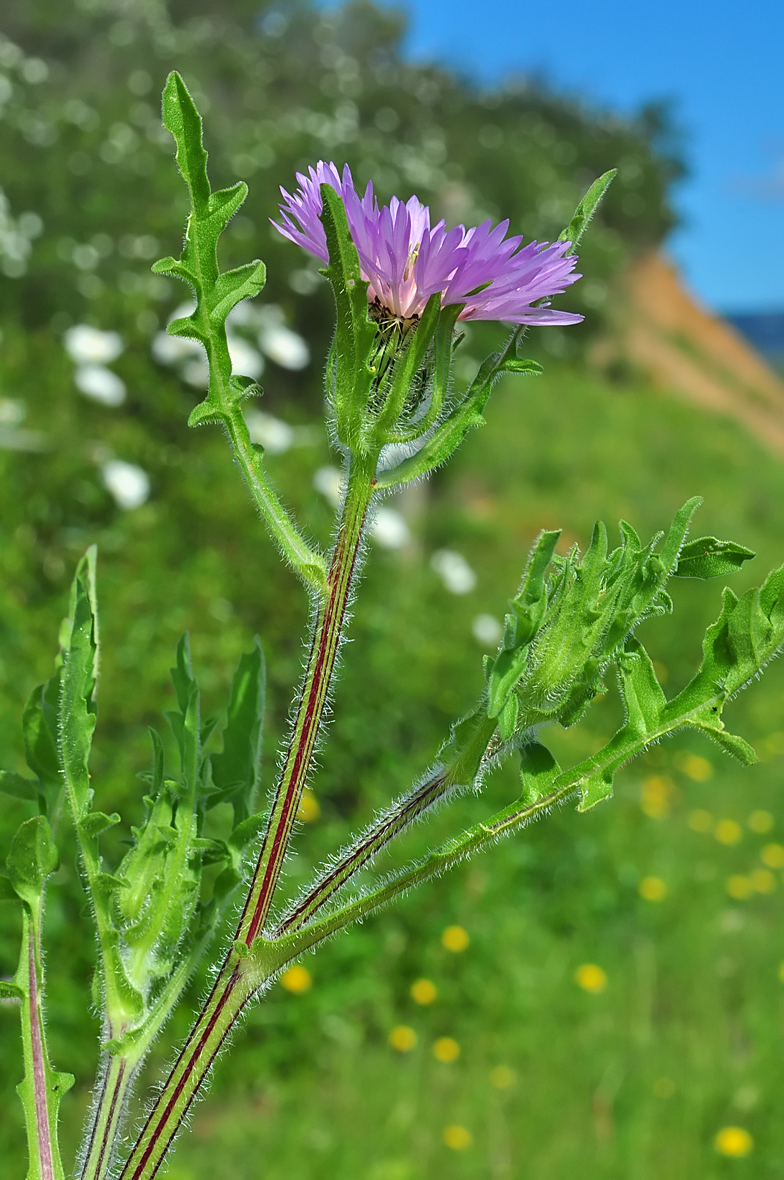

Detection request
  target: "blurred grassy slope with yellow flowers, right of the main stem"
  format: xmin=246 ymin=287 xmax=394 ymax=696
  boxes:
xmin=168 ymin=372 xmax=784 ymax=1180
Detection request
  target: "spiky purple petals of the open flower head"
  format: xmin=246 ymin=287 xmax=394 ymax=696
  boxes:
xmin=273 ymin=160 xmax=582 ymax=325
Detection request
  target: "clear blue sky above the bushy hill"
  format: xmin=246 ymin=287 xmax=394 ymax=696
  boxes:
xmin=321 ymin=0 xmax=784 ymax=312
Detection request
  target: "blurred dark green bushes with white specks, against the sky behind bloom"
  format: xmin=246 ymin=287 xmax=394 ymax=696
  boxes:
xmin=0 ymin=0 xmax=681 ymax=344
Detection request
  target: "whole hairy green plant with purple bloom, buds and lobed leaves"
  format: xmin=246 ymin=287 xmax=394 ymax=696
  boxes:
xmin=0 ymin=74 xmax=784 ymax=1180
